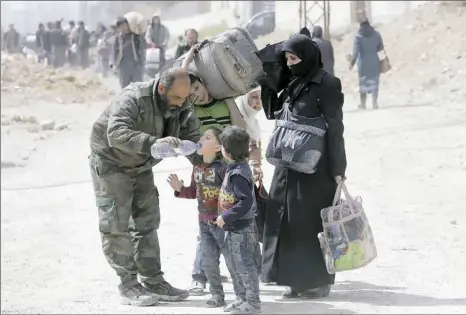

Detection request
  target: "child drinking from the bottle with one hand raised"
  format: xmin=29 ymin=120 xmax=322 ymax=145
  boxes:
xmin=168 ymin=127 xmax=226 ymax=307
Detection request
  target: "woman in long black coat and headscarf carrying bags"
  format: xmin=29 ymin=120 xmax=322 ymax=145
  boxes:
xmin=262 ymin=34 xmax=346 ymax=298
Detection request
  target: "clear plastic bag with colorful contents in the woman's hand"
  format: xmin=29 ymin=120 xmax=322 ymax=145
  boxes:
xmin=318 ymin=182 xmax=377 ymax=274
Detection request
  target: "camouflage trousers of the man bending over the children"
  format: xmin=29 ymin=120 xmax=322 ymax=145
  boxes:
xmin=89 ymin=154 xmax=164 ymax=288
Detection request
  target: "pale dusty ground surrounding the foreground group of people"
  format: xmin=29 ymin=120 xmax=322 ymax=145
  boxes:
xmin=1 ymin=3 xmax=466 ymax=314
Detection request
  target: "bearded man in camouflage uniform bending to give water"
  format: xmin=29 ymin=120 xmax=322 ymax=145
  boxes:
xmin=89 ymin=68 xmax=200 ymax=306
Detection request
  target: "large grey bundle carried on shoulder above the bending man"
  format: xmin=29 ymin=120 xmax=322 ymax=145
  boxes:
xmin=174 ymin=27 xmax=263 ymax=99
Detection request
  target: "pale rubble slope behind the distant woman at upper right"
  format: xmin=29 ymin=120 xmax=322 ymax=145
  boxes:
xmin=333 ymin=1 xmax=466 ymax=105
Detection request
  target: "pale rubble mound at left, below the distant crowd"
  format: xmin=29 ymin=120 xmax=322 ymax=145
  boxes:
xmin=1 ymin=54 xmax=113 ymax=103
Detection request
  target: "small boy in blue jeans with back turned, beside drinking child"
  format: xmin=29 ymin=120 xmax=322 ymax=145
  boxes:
xmin=216 ymin=126 xmax=261 ymax=314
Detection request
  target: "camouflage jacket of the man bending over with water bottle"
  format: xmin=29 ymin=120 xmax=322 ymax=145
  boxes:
xmin=91 ymin=80 xmax=200 ymax=169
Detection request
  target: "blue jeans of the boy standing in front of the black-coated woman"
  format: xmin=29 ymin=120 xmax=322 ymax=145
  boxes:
xmin=224 ymin=225 xmax=261 ymax=307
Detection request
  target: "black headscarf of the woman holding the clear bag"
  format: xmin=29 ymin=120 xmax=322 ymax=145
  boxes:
xmin=282 ymin=34 xmax=324 ymax=96
